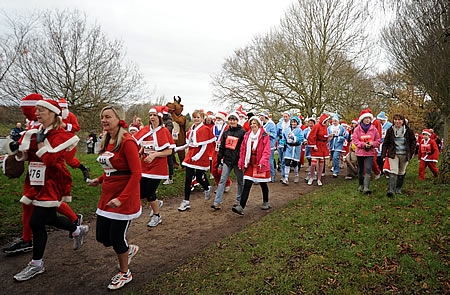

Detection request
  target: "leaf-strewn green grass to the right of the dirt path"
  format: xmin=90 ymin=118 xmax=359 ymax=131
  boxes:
xmin=141 ymin=160 xmax=450 ymax=294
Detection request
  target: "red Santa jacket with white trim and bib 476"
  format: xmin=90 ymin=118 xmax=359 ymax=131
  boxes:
xmin=18 ymin=125 xmax=79 ymax=207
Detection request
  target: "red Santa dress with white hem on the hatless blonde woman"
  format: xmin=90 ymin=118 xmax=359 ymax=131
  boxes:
xmin=96 ymin=133 xmax=142 ymax=220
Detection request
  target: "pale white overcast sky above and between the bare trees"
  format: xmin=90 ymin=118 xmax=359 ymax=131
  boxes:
xmin=0 ymin=0 xmax=295 ymax=113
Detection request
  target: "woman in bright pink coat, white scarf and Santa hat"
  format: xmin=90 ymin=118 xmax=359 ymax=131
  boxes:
xmin=231 ymin=117 xmax=271 ymax=215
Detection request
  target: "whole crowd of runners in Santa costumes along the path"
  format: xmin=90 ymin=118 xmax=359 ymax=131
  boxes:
xmin=3 ymin=94 xmax=440 ymax=290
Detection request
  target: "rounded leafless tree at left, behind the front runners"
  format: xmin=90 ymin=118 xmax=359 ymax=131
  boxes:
xmin=0 ymin=10 xmax=149 ymax=130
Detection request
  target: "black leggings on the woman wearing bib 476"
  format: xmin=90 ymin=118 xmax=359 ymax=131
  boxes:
xmin=30 ymin=206 xmax=77 ymax=260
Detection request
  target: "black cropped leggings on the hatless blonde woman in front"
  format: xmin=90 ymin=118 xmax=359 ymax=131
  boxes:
xmin=95 ymin=215 xmax=131 ymax=254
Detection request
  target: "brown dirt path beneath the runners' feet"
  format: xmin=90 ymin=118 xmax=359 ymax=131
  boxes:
xmin=0 ymin=169 xmax=331 ymax=294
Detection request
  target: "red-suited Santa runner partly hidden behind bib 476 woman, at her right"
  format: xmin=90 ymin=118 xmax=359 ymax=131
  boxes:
xmin=58 ymin=98 xmax=90 ymax=181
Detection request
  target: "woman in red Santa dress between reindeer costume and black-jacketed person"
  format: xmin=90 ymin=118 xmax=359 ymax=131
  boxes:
xmin=175 ymin=110 xmax=216 ymax=211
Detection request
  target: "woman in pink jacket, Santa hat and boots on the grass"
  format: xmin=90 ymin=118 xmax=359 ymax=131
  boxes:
xmin=352 ymin=109 xmax=381 ymax=194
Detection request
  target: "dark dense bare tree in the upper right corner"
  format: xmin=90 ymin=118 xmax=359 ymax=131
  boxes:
xmin=383 ymin=0 xmax=450 ymax=181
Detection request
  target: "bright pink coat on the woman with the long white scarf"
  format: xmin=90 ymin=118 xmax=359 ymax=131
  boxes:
xmin=238 ymin=127 xmax=271 ymax=172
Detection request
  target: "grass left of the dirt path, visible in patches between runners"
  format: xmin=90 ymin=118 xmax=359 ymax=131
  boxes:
xmin=0 ymin=153 xmax=192 ymax=243
